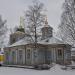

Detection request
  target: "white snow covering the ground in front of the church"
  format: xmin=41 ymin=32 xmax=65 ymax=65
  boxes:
xmin=0 ymin=65 xmax=75 ymax=75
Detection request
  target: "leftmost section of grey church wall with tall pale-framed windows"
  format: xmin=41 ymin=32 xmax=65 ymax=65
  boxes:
xmin=4 ymin=46 xmax=25 ymax=65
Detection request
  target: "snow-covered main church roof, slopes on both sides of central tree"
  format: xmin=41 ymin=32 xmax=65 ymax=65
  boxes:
xmin=9 ymin=37 xmax=67 ymax=47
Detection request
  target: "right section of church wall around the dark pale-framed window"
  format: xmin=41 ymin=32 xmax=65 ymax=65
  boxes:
xmin=47 ymin=45 xmax=64 ymax=64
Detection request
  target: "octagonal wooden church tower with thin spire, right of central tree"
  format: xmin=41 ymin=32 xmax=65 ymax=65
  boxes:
xmin=41 ymin=17 xmax=53 ymax=39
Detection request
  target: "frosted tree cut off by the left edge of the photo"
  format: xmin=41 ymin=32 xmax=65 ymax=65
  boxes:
xmin=0 ymin=15 xmax=7 ymax=47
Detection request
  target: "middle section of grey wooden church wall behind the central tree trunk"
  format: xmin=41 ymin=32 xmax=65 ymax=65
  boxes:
xmin=26 ymin=45 xmax=45 ymax=65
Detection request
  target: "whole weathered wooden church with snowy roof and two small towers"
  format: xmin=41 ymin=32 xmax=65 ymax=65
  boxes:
xmin=4 ymin=16 xmax=71 ymax=66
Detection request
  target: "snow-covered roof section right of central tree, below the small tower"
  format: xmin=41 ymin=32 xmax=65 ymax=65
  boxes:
xmin=38 ymin=37 xmax=67 ymax=44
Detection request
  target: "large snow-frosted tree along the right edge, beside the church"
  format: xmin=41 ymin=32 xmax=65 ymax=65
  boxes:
xmin=59 ymin=0 xmax=75 ymax=45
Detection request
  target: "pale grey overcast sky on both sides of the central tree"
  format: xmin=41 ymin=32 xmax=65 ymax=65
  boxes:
xmin=0 ymin=0 xmax=64 ymax=30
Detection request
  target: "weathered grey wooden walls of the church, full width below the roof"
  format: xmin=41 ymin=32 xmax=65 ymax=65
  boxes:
xmin=4 ymin=45 xmax=71 ymax=65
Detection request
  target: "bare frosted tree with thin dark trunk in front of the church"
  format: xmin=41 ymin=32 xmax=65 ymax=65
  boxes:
xmin=25 ymin=0 xmax=45 ymax=62
